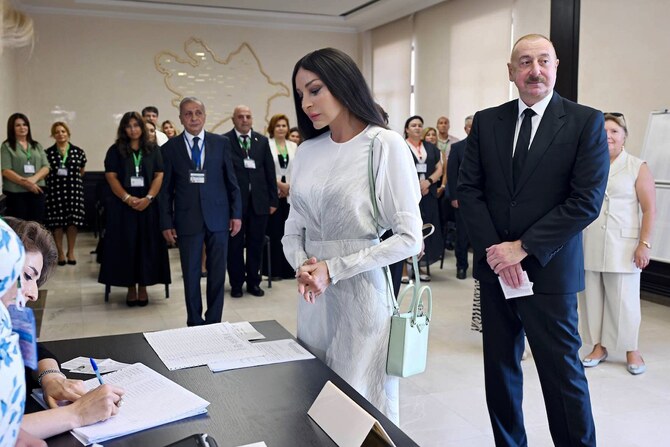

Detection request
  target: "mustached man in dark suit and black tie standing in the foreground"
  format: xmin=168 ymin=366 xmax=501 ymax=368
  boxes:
xmin=458 ymin=34 xmax=609 ymax=446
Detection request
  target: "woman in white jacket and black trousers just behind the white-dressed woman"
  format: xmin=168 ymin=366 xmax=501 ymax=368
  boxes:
xmin=261 ymin=114 xmax=298 ymax=279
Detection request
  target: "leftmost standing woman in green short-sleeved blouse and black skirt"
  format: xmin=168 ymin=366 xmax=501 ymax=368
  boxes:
xmin=0 ymin=113 xmax=49 ymax=223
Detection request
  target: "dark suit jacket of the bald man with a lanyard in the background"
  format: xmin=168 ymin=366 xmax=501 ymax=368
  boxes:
xmin=224 ymin=129 xmax=279 ymax=216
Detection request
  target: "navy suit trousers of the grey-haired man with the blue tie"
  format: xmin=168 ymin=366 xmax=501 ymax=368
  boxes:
xmin=179 ymin=230 xmax=228 ymax=326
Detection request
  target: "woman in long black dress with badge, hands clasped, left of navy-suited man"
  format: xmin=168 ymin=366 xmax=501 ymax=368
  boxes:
xmin=98 ymin=112 xmax=170 ymax=306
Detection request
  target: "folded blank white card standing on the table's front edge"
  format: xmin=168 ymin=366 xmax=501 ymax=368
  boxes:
xmin=307 ymin=380 xmax=395 ymax=447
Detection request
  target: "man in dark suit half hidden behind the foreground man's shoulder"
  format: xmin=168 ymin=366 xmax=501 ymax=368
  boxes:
xmin=447 ymin=115 xmax=472 ymax=279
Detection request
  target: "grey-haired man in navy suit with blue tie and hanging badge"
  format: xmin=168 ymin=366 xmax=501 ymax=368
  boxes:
xmin=159 ymin=98 xmax=242 ymax=326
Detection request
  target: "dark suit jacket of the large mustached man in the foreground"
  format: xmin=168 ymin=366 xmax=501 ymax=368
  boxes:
xmin=457 ymin=92 xmax=609 ymax=294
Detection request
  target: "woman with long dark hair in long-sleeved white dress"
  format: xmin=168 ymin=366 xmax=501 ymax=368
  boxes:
xmin=282 ymin=48 xmax=422 ymax=424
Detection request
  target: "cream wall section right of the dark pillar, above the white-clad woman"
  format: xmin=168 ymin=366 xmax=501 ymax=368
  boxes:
xmin=578 ymin=0 xmax=670 ymax=158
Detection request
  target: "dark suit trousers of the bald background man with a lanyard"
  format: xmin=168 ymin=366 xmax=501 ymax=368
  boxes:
xmin=228 ymin=196 xmax=269 ymax=289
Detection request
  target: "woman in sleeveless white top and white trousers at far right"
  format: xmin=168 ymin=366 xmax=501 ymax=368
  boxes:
xmin=579 ymin=113 xmax=656 ymax=375
